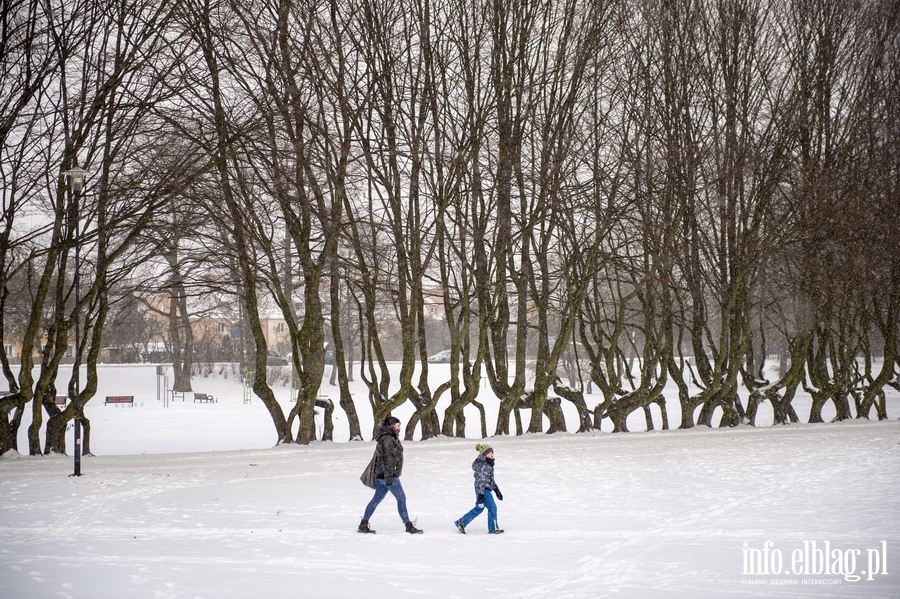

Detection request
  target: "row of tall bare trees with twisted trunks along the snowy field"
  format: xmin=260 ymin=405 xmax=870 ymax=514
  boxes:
xmin=0 ymin=0 xmax=900 ymax=453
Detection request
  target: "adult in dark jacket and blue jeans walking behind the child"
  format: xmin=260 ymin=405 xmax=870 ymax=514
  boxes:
xmin=359 ymin=416 xmax=422 ymax=534
